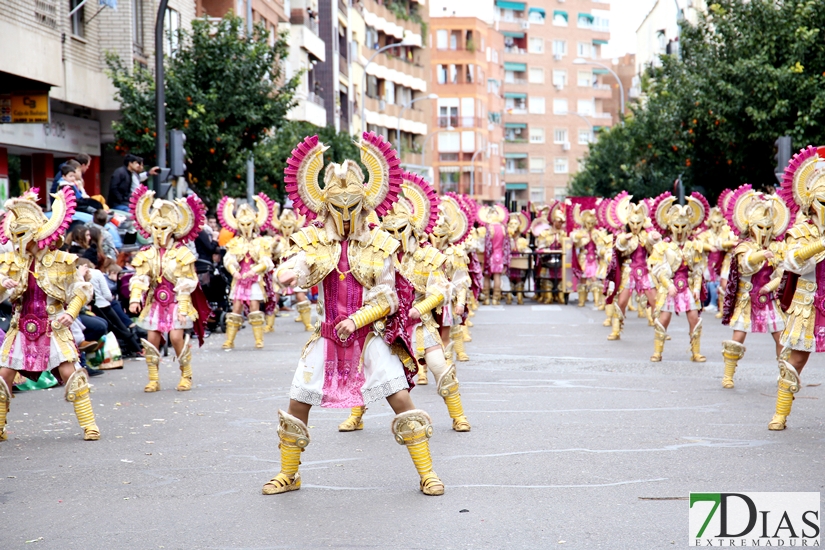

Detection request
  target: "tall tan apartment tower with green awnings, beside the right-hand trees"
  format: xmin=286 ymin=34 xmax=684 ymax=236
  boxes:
xmin=495 ymin=0 xmax=615 ymax=203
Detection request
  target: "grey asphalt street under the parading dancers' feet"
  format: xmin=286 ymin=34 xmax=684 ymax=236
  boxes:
xmin=0 ymin=302 xmax=825 ymax=550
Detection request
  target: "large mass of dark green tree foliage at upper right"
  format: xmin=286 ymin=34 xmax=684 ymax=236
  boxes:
xmin=570 ymin=0 xmax=825 ymax=203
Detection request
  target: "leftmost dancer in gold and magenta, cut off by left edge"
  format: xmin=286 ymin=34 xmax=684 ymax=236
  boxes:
xmin=0 ymin=187 xmax=100 ymax=441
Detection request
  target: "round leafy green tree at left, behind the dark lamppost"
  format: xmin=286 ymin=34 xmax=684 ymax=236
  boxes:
xmin=106 ymin=15 xmax=301 ymax=208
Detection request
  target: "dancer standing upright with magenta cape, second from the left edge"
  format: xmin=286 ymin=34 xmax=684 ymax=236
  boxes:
xmin=129 ymin=185 xmax=210 ymax=393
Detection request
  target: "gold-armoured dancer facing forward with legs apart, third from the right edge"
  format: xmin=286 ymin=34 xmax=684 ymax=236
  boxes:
xmin=648 ymin=192 xmax=710 ymax=363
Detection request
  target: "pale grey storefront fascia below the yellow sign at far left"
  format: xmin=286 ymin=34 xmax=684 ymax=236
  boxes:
xmin=0 ymin=113 xmax=100 ymax=156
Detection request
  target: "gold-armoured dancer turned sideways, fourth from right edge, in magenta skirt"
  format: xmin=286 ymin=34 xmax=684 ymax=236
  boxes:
xmin=607 ymin=191 xmax=662 ymax=340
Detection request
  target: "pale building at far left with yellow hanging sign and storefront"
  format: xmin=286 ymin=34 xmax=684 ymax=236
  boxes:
xmin=0 ymin=0 xmax=195 ymax=201
